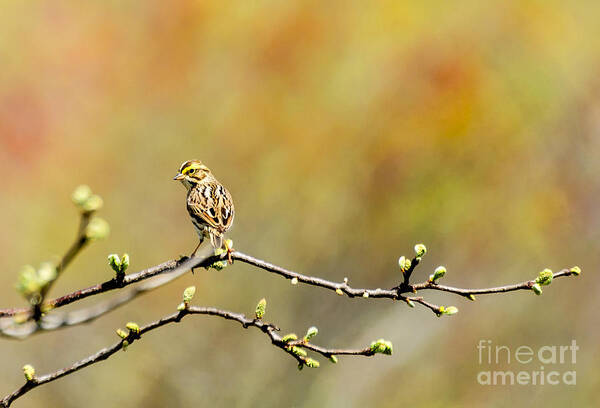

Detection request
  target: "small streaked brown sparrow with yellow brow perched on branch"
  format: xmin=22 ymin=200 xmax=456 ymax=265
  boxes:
xmin=173 ymin=160 xmax=235 ymax=263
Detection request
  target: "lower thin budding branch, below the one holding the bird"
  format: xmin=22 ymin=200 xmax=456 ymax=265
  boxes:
xmin=0 ymin=306 xmax=375 ymax=408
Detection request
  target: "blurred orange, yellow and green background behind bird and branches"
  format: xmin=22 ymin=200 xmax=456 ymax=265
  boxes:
xmin=0 ymin=0 xmax=600 ymax=407
